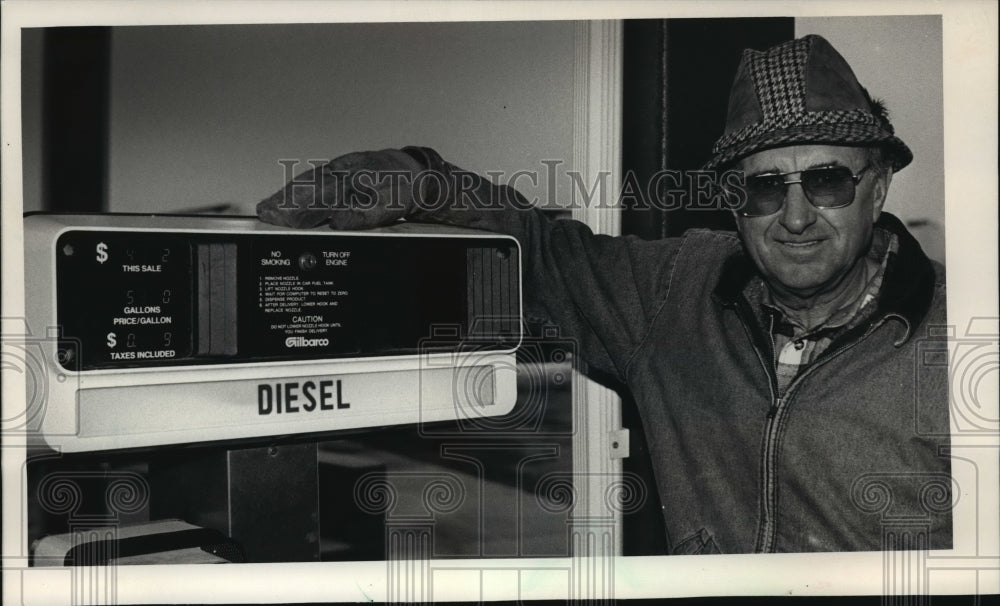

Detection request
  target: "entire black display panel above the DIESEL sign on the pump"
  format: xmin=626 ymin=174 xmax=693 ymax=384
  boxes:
xmin=56 ymin=230 xmax=518 ymax=370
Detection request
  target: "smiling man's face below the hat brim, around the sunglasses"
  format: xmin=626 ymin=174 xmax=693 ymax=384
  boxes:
xmin=736 ymin=145 xmax=891 ymax=300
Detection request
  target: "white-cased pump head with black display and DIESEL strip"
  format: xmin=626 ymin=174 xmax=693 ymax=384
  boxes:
xmin=25 ymin=214 xmax=521 ymax=450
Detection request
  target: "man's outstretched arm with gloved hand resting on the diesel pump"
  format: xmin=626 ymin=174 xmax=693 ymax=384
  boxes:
xmin=257 ymin=147 xmax=677 ymax=379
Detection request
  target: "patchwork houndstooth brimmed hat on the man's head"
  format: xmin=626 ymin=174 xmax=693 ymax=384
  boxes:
xmin=704 ymin=35 xmax=913 ymax=171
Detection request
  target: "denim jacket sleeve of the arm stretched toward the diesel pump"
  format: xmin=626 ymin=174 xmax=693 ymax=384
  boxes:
xmin=403 ymin=147 xmax=680 ymax=381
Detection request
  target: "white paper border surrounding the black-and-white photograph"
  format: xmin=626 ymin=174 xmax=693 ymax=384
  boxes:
xmin=0 ymin=0 xmax=1000 ymax=604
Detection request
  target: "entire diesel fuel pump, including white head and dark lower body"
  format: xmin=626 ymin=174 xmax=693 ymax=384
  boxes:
xmin=24 ymin=214 xmax=522 ymax=566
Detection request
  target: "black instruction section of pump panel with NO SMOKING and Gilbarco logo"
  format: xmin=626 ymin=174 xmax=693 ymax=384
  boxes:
xmin=239 ymin=234 xmax=519 ymax=358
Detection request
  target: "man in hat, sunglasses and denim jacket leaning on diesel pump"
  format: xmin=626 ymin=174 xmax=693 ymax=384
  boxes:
xmin=258 ymin=36 xmax=951 ymax=554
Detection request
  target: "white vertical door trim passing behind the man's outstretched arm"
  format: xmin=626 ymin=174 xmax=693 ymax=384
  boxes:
xmin=571 ymin=20 xmax=624 ymax=572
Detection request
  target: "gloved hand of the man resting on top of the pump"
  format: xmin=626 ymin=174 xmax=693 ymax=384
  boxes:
xmin=257 ymin=149 xmax=424 ymax=230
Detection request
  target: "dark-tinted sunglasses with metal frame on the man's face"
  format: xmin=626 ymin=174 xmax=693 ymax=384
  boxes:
xmin=739 ymin=164 xmax=871 ymax=217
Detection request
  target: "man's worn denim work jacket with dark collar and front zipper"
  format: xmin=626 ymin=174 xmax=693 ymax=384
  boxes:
xmin=411 ymin=152 xmax=952 ymax=553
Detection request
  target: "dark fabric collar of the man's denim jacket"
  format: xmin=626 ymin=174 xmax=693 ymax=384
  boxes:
xmin=712 ymin=212 xmax=935 ymax=340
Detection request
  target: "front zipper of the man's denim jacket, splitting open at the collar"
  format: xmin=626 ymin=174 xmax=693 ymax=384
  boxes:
xmin=742 ymin=304 xmax=886 ymax=553
